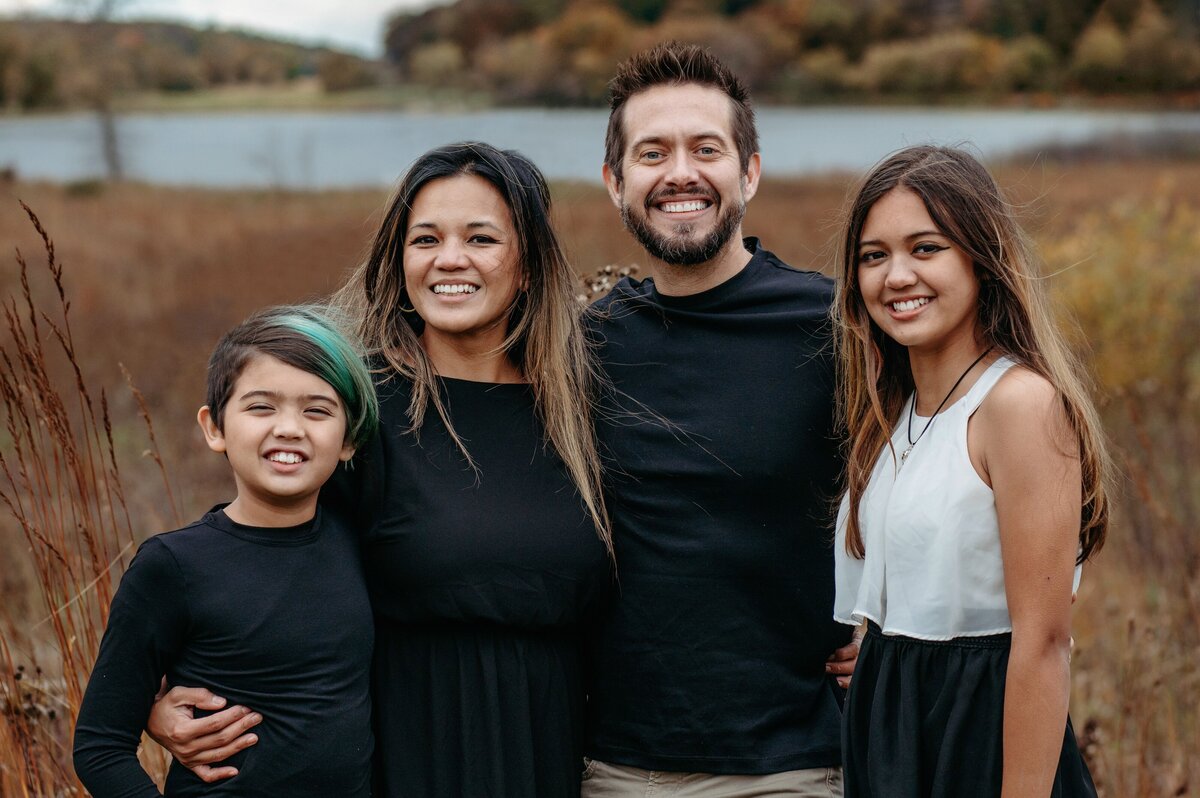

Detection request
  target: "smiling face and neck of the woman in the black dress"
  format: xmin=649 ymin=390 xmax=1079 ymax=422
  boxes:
xmin=404 ymin=174 xmax=523 ymax=348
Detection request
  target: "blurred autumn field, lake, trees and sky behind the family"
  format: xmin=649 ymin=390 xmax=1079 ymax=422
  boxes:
xmin=0 ymin=0 xmax=1200 ymax=797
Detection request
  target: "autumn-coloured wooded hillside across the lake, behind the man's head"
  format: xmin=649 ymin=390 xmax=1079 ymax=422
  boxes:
xmin=385 ymin=0 xmax=1200 ymax=104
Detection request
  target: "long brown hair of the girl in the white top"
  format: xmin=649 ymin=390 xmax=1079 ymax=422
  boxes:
xmin=834 ymin=146 xmax=1111 ymax=562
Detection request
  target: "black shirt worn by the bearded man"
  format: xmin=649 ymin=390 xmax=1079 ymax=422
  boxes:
xmin=588 ymin=239 xmax=848 ymax=774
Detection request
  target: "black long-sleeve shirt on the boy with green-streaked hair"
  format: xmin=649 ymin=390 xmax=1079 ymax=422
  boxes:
xmin=74 ymin=510 xmax=373 ymax=798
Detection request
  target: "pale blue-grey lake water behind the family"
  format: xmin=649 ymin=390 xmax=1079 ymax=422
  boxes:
xmin=0 ymin=108 xmax=1200 ymax=188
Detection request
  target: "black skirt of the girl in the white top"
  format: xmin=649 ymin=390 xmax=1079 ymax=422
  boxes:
xmin=841 ymin=623 xmax=1096 ymax=798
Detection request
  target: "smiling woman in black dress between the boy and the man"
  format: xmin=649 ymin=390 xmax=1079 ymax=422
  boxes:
xmin=151 ymin=144 xmax=612 ymax=798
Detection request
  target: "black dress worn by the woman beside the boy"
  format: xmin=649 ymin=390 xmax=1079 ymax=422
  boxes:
xmin=356 ymin=377 xmax=611 ymax=798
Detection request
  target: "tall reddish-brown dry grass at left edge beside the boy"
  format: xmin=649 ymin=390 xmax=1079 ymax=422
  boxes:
xmin=0 ymin=203 xmax=178 ymax=796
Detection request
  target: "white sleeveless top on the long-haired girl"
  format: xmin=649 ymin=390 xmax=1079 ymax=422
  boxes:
xmin=834 ymin=356 xmax=1081 ymax=640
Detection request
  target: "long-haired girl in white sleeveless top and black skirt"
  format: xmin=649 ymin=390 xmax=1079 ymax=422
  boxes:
xmin=835 ymin=146 xmax=1109 ymax=798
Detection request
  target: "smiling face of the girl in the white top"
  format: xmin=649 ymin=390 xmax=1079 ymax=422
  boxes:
xmin=858 ymin=186 xmax=979 ymax=352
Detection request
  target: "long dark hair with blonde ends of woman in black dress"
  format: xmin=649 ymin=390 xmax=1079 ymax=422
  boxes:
xmin=334 ymin=142 xmax=612 ymax=557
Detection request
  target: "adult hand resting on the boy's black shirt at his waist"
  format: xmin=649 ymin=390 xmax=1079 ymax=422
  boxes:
xmin=146 ymin=688 xmax=263 ymax=782
